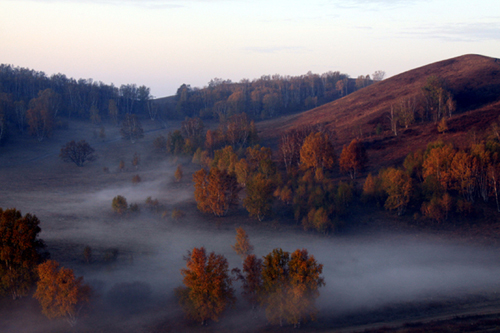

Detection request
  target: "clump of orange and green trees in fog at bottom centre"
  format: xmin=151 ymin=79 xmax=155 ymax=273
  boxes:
xmin=176 ymin=244 xmax=325 ymax=328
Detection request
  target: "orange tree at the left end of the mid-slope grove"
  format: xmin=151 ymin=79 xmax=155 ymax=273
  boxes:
xmin=193 ymin=167 xmax=240 ymax=217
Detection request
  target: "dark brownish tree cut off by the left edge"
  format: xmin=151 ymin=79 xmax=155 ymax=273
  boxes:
xmin=0 ymin=208 xmax=45 ymax=299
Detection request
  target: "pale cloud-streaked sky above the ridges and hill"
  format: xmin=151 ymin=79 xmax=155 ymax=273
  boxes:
xmin=0 ymin=0 xmax=500 ymax=97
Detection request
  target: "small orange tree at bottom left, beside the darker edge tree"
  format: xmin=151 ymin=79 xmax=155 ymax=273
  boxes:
xmin=33 ymin=260 xmax=90 ymax=326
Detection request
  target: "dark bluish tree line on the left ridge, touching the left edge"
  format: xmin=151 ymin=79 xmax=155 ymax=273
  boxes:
xmin=0 ymin=64 xmax=153 ymax=143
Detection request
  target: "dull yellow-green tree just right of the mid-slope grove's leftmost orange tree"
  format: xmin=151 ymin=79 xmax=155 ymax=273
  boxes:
xmin=243 ymin=173 xmax=275 ymax=221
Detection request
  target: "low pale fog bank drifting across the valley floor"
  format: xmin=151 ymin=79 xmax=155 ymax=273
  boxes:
xmin=3 ymin=162 xmax=500 ymax=331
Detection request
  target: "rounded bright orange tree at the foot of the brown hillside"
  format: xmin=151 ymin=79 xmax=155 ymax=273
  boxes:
xmin=300 ymin=132 xmax=336 ymax=170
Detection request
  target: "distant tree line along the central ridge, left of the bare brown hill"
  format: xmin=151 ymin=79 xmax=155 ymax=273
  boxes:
xmin=172 ymin=71 xmax=385 ymax=120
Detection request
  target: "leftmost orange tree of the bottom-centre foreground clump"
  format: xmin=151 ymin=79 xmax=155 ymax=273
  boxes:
xmin=176 ymin=247 xmax=235 ymax=325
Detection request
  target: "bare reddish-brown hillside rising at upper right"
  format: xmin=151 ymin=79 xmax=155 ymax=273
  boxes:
xmin=259 ymin=55 xmax=500 ymax=169
